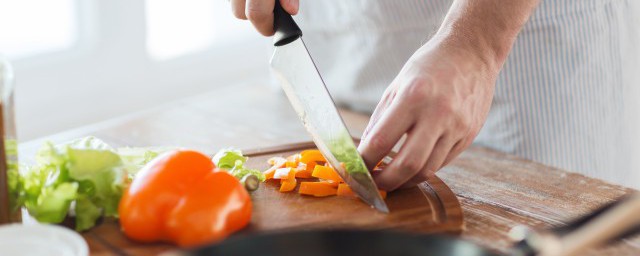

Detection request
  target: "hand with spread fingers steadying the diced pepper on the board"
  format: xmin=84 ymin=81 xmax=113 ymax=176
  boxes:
xmin=359 ymin=38 xmax=497 ymax=191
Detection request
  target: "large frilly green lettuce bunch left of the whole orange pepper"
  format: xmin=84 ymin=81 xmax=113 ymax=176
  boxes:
xmin=14 ymin=137 xmax=126 ymax=231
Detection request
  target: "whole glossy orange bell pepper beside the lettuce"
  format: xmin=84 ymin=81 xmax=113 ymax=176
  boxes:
xmin=118 ymin=150 xmax=251 ymax=247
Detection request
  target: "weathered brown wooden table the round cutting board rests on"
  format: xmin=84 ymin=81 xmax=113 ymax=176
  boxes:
xmin=20 ymin=84 xmax=640 ymax=255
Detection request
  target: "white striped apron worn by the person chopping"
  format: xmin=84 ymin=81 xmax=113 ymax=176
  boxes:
xmin=296 ymin=0 xmax=640 ymax=188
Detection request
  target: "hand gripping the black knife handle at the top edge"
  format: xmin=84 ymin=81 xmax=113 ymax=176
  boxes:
xmin=231 ymin=0 xmax=300 ymax=36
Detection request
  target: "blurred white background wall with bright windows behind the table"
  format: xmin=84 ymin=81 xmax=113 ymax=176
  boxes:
xmin=0 ymin=0 xmax=269 ymax=141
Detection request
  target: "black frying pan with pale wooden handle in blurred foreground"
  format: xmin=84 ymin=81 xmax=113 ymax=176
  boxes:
xmin=184 ymin=195 xmax=640 ymax=256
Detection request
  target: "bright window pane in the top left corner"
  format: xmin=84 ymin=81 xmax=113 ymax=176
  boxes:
xmin=0 ymin=0 xmax=77 ymax=59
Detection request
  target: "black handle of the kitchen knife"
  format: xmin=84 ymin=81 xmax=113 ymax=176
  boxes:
xmin=273 ymin=0 xmax=302 ymax=46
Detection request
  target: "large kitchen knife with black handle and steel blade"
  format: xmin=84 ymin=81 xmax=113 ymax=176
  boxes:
xmin=271 ymin=0 xmax=389 ymax=213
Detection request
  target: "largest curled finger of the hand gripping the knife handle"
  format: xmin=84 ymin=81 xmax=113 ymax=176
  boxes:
xmin=245 ymin=0 xmax=275 ymax=36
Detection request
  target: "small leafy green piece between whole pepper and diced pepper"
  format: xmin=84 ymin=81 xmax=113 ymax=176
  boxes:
xmin=212 ymin=148 xmax=266 ymax=182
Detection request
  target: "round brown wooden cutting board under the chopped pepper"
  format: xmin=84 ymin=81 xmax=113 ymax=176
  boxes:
xmin=82 ymin=142 xmax=464 ymax=255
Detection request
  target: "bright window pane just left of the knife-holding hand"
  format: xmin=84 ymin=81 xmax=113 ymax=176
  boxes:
xmin=146 ymin=0 xmax=252 ymax=60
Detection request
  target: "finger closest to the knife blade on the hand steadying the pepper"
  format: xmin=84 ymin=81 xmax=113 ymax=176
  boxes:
xmin=358 ymin=104 xmax=414 ymax=168
